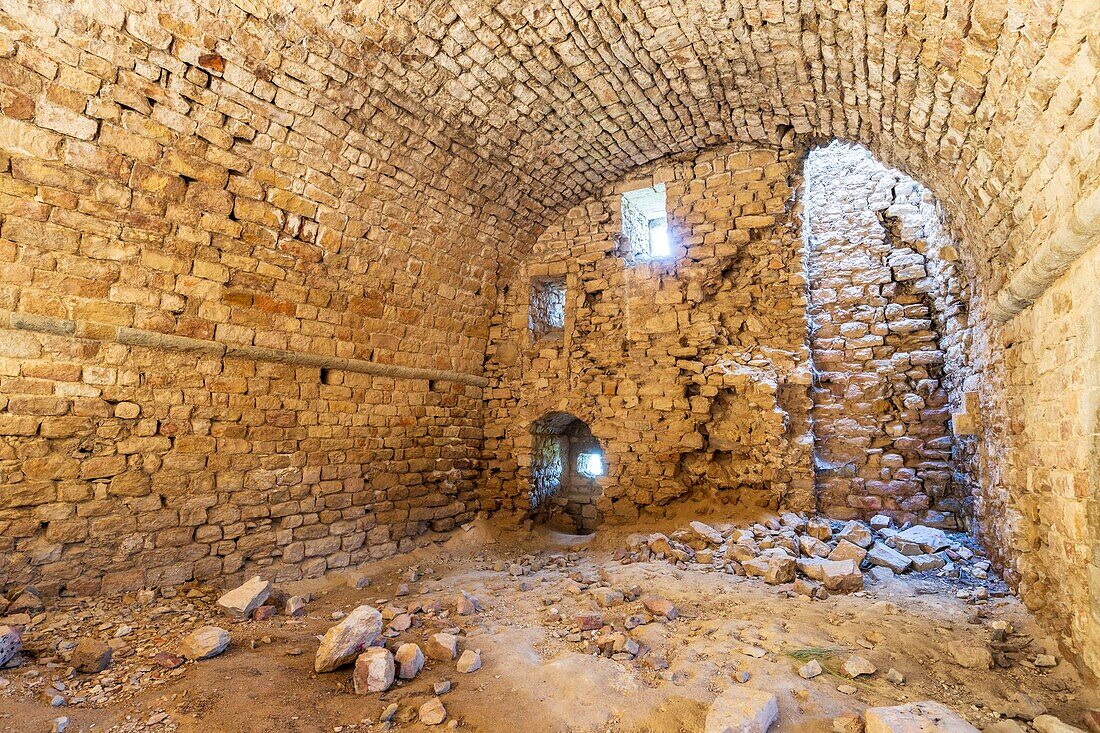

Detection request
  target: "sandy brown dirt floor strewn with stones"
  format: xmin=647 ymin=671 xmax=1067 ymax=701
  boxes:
xmin=0 ymin=508 xmax=1100 ymax=733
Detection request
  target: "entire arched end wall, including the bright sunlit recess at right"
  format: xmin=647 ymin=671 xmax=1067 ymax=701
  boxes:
xmin=484 ymin=143 xmax=974 ymax=527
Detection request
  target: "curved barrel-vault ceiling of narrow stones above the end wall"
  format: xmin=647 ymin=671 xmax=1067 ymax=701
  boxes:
xmin=297 ymin=0 xmax=1100 ymax=278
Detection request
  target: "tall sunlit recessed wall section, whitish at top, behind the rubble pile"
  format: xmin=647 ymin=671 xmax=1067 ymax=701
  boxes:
xmin=805 ymin=143 xmax=970 ymax=527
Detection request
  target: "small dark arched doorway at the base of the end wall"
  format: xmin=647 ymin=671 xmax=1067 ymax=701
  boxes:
xmin=530 ymin=412 xmax=605 ymax=535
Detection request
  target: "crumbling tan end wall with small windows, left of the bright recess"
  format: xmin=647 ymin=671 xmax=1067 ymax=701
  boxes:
xmin=483 ymin=140 xmax=813 ymax=521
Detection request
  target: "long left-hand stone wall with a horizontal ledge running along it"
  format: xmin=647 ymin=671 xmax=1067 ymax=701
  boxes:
xmin=0 ymin=0 xmax=514 ymax=592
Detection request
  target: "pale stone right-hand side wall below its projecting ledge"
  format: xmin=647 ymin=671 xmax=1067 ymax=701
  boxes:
xmin=971 ymin=249 xmax=1100 ymax=671
